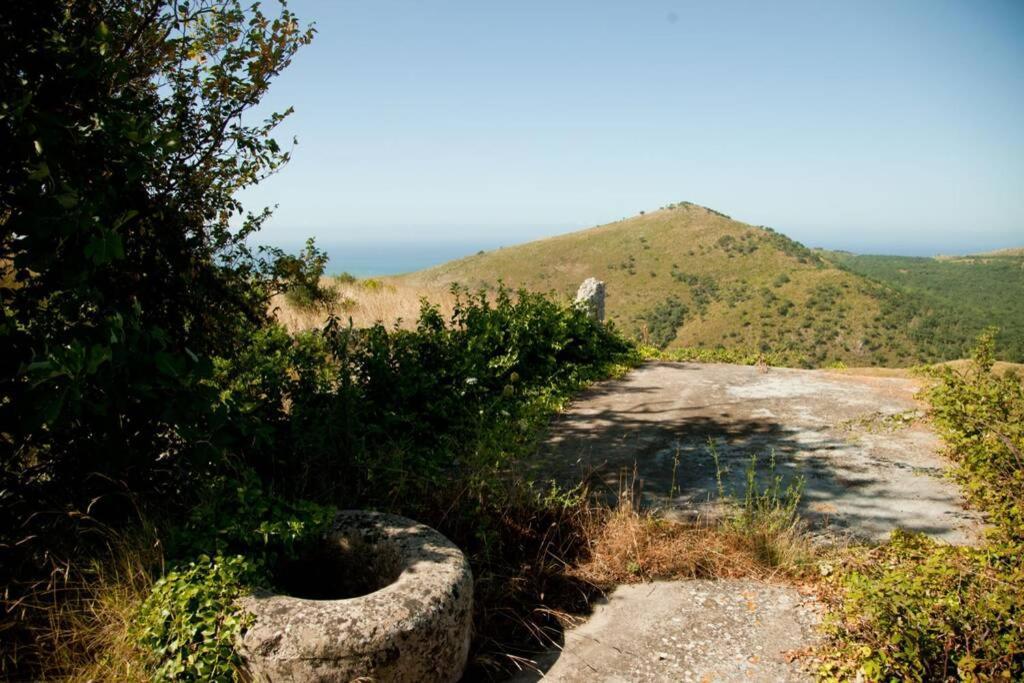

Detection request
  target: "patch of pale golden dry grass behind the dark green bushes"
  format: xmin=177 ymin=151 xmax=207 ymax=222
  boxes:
xmin=271 ymin=278 xmax=455 ymax=332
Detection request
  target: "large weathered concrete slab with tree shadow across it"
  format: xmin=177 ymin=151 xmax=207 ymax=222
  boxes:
xmin=535 ymin=362 xmax=981 ymax=544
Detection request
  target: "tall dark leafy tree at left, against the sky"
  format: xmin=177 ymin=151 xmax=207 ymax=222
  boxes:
xmin=0 ymin=0 xmax=312 ymax=667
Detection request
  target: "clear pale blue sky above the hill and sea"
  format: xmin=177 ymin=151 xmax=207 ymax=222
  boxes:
xmin=244 ymin=0 xmax=1024 ymax=254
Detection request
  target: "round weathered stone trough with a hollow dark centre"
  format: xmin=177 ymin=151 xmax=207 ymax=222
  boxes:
xmin=239 ymin=510 xmax=473 ymax=683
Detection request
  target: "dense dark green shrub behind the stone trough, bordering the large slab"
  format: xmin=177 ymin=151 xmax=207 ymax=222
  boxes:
xmin=199 ymin=289 xmax=632 ymax=679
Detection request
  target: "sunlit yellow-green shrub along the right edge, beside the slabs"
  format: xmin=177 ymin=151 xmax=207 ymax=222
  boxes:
xmin=822 ymin=333 xmax=1024 ymax=681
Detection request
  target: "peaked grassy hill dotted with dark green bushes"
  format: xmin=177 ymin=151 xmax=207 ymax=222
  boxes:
xmin=403 ymin=202 xmax=999 ymax=366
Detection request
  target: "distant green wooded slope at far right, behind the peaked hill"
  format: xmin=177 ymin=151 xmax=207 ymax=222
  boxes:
xmin=824 ymin=249 xmax=1024 ymax=361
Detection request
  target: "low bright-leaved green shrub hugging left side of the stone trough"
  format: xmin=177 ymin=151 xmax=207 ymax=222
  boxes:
xmin=133 ymin=470 xmax=334 ymax=681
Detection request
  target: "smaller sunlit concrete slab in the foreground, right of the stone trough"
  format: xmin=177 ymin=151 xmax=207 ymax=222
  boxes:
xmin=512 ymin=581 xmax=820 ymax=683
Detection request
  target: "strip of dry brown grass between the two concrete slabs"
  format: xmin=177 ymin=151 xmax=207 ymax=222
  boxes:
xmin=470 ymin=481 xmax=821 ymax=678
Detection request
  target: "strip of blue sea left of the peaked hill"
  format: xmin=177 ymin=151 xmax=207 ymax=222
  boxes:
xmin=274 ymin=240 xmax=502 ymax=278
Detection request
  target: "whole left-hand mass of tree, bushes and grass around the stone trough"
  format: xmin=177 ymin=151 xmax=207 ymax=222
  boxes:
xmin=0 ymin=5 xmax=637 ymax=682
